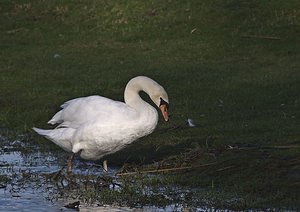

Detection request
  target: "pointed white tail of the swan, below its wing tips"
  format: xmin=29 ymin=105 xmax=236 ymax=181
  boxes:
xmin=32 ymin=127 xmax=74 ymax=152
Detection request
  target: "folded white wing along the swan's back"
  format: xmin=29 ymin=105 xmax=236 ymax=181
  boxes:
xmin=48 ymin=96 xmax=136 ymax=128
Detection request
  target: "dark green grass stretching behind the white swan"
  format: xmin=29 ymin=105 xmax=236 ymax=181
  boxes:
xmin=0 ymin=0 xmax=300 ymax=209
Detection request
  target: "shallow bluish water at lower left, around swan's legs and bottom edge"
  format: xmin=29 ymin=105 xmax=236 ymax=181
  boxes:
xmin=0 ymin=139 xmax=205 ymax=211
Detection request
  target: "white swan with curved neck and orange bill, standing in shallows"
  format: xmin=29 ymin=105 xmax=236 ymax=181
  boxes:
xmin=33 ymin=76 xmax=169 ymax=172
